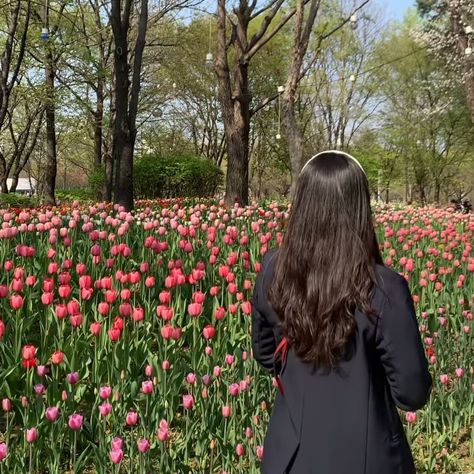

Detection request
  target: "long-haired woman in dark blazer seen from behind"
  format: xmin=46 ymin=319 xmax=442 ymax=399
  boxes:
xmin=252 ymin=151 xmax=432 ymax=474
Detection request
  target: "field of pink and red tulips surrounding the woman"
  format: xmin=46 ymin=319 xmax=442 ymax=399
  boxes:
xmin=0 ymin=200 xmax=474 ymax=474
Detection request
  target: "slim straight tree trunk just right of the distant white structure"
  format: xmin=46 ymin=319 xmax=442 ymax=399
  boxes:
xmin=43 ymin=45 xmax=57 ymax=206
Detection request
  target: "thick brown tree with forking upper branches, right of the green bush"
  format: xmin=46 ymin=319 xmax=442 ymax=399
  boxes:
xmin=215 ymin=0 xmax=295 ymax=205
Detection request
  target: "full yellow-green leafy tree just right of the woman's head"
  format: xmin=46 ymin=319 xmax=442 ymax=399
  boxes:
xmin=372 ymin=12 xmax=472 ymax=204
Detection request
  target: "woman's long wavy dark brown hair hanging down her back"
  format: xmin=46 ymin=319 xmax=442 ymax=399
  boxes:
xmin=268 ymin=152 xmax=383 ymax=367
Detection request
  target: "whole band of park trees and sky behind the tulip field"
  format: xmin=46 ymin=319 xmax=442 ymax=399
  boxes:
xmin=0 ymin=0 xmax=474 ymax=209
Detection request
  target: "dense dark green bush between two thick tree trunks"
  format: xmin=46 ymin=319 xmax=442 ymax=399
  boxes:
xmin=134 ymin=155 xmax=224 ymax=199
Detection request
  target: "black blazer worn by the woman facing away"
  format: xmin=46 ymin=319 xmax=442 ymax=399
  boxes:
xmin=252 ymin=249 xmax=432 ymax=474
